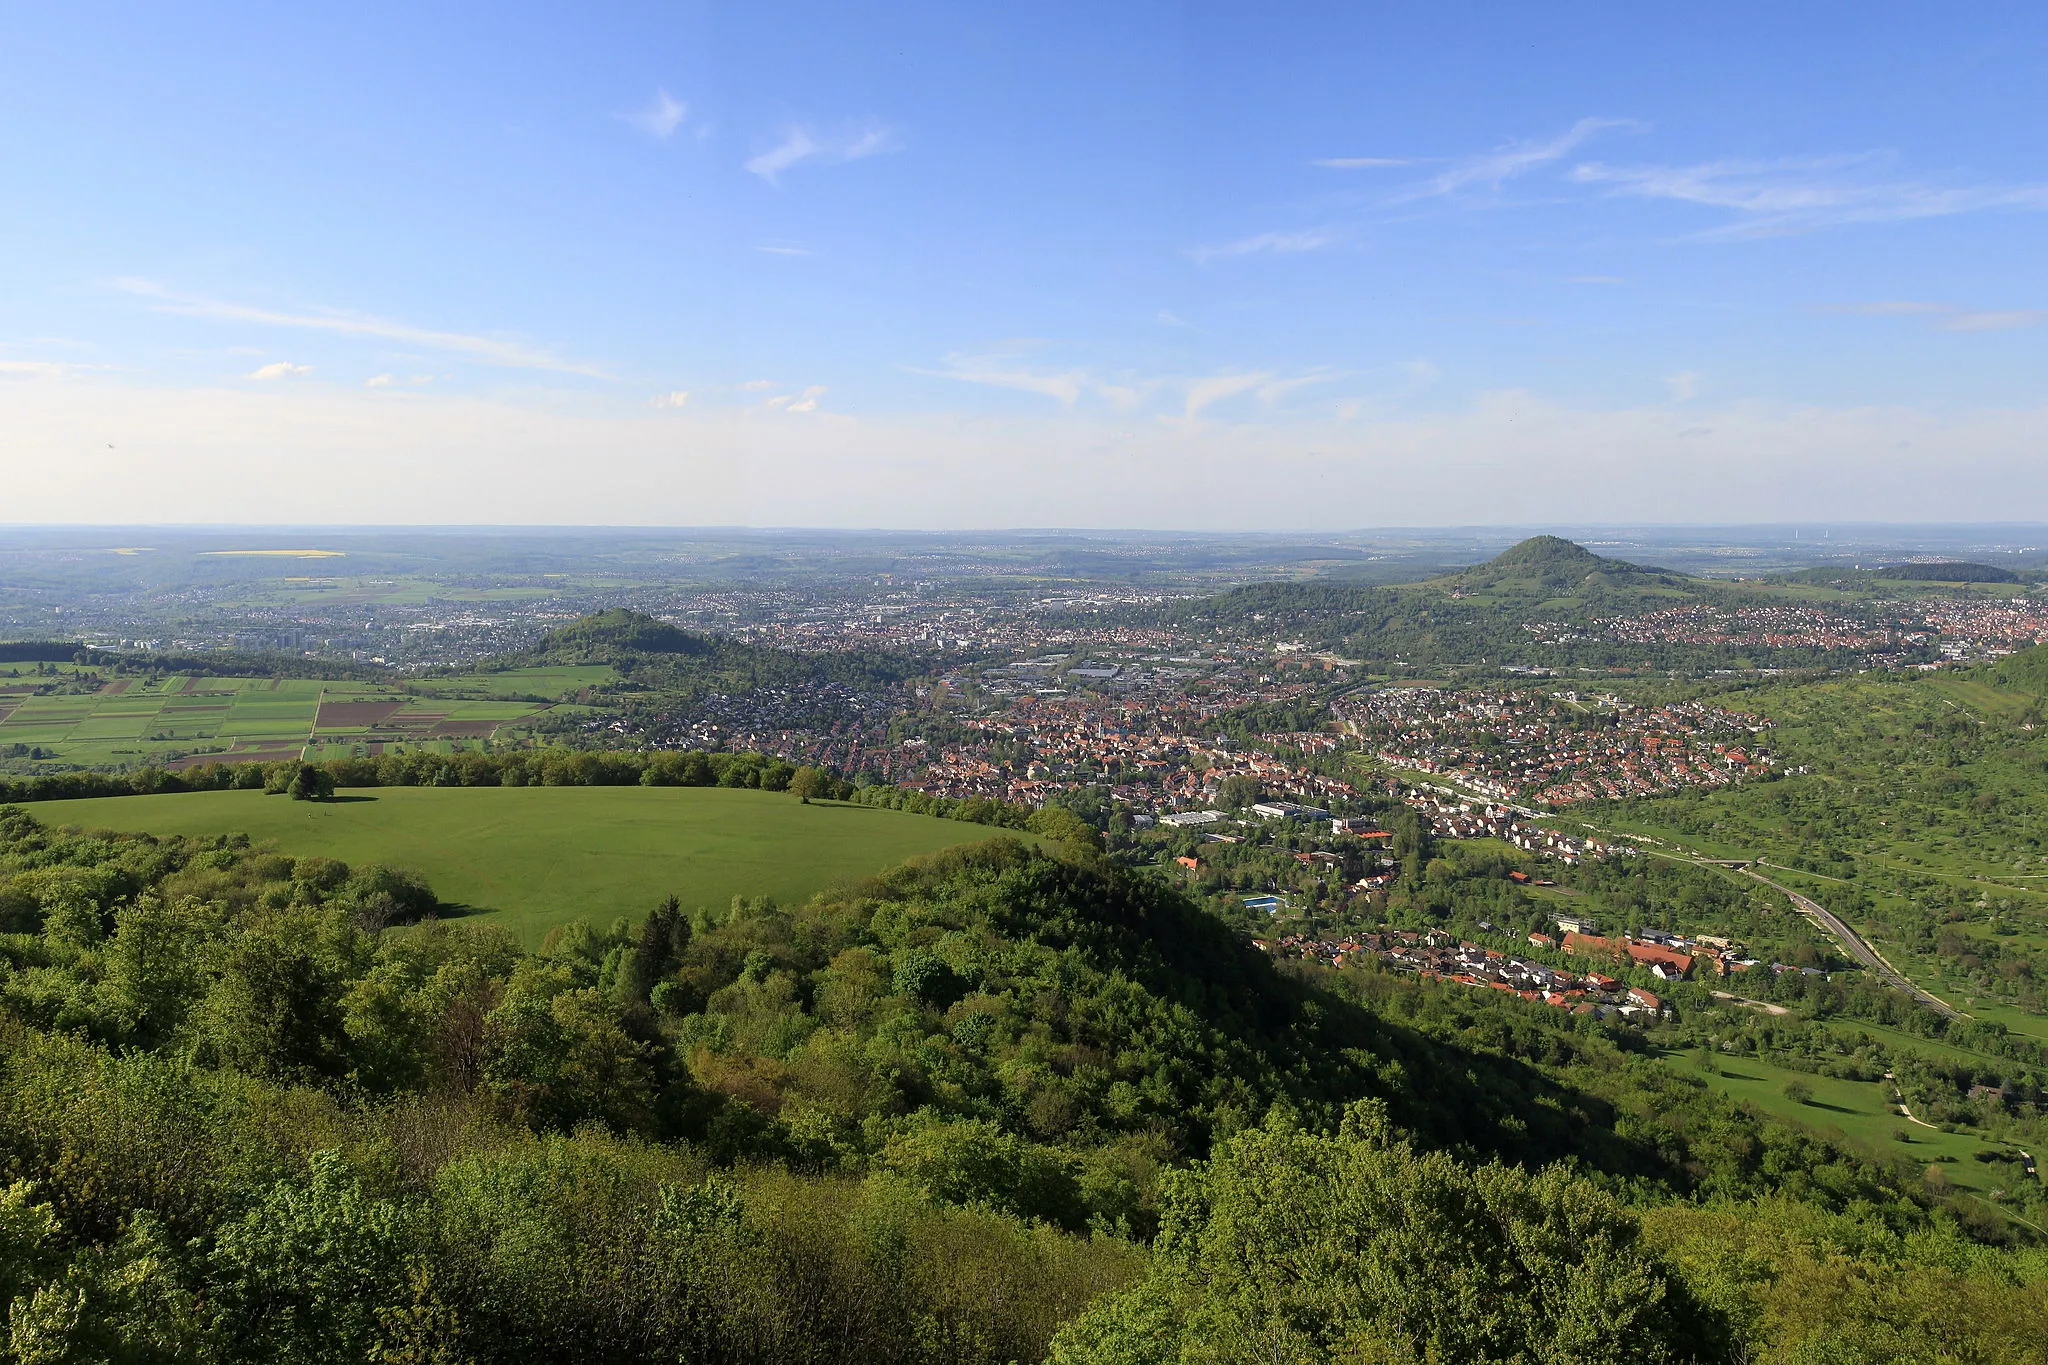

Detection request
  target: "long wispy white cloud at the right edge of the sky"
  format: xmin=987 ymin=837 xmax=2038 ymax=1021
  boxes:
xmin=1571 ymin=151 xmax=2048 ymax=237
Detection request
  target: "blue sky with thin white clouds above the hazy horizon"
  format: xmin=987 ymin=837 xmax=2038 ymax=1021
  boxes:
xmin=0 ymin=4 xmax=2048 ymax=528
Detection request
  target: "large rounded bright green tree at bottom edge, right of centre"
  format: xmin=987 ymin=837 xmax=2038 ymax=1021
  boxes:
xmin=1049 ymin=1101 xmax=1726 ymax=1365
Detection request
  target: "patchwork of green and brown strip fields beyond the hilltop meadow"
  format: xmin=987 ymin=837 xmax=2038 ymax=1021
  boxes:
xmin=0 ymin=669 xmax=561 ymax=767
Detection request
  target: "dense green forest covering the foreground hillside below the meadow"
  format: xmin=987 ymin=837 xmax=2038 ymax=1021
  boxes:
xmin=0 ymin=796 xmax=2048 ymax=1363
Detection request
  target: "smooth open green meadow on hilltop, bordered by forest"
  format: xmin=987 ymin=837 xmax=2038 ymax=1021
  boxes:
xmin=29 ymin=786 xmax=1032 ymax=943
